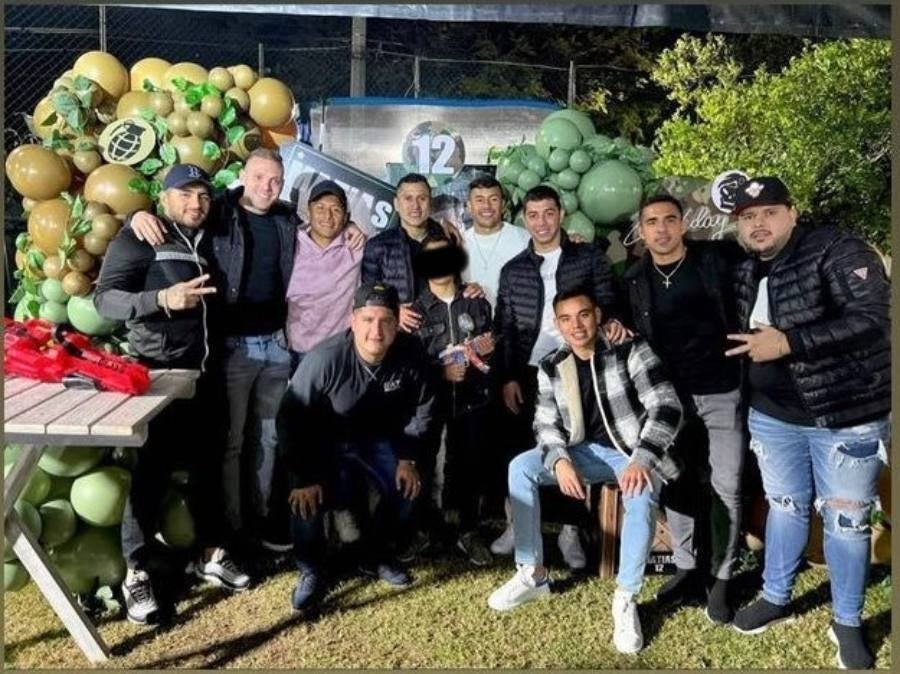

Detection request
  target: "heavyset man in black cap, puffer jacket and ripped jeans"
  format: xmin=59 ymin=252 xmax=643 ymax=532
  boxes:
xmin=727 ymin=177 xmax=891 ymax=669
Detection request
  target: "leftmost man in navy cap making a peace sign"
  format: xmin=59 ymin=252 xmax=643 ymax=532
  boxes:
xmin=94 ymin=164 xmax=250 ymax=624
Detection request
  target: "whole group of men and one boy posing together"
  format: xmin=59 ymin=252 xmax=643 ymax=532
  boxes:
xmin=95 ymin=143 xmax=890 ymax=668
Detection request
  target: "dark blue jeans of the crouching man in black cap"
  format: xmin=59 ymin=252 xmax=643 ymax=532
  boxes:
xmin=291 ymin=440 xmax=413 ymax=571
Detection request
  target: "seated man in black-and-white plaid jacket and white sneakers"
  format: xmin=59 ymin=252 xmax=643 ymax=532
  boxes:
xmin=488 ymin=289 xmax=682 ymax=653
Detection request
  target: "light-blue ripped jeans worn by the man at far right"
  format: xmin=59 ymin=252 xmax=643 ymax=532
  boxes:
xmin=748 ymin=408 xmax=890 ymax=627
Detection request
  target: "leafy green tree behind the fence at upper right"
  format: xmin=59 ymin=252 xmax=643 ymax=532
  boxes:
xmin=652 ymin=38 xmax=891 ymax=250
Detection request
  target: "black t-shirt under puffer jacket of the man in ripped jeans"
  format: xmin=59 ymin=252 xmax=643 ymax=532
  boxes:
xmin=748 ymin=260 xmax=816 ymax=426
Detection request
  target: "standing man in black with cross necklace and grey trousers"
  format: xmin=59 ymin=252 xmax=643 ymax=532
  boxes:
xmin=625 ymin=194 xmax=744 ymax=624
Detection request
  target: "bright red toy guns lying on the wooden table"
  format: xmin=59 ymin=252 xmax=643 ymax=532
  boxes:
xmin=3 ymin=318 xmax=150 ymax=395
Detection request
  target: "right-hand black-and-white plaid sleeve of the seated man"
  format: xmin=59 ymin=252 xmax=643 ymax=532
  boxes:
xmin=628 ymin=340 xmax=682 ymax=467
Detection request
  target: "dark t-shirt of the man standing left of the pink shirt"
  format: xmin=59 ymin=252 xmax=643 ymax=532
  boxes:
xmin=225 ymin=209 xmax=286 ymax=335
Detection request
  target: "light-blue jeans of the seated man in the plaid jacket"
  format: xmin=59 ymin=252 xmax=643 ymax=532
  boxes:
xmin=509 ymin=442 xmax=662 ymax=594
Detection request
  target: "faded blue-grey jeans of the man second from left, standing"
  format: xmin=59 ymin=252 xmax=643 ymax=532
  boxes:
xmin=222 ymin=330 xmax=290 ymax=531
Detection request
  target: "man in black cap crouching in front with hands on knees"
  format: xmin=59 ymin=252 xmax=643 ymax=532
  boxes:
xmin=277 ymin=283 xmax=434 ymax=611
